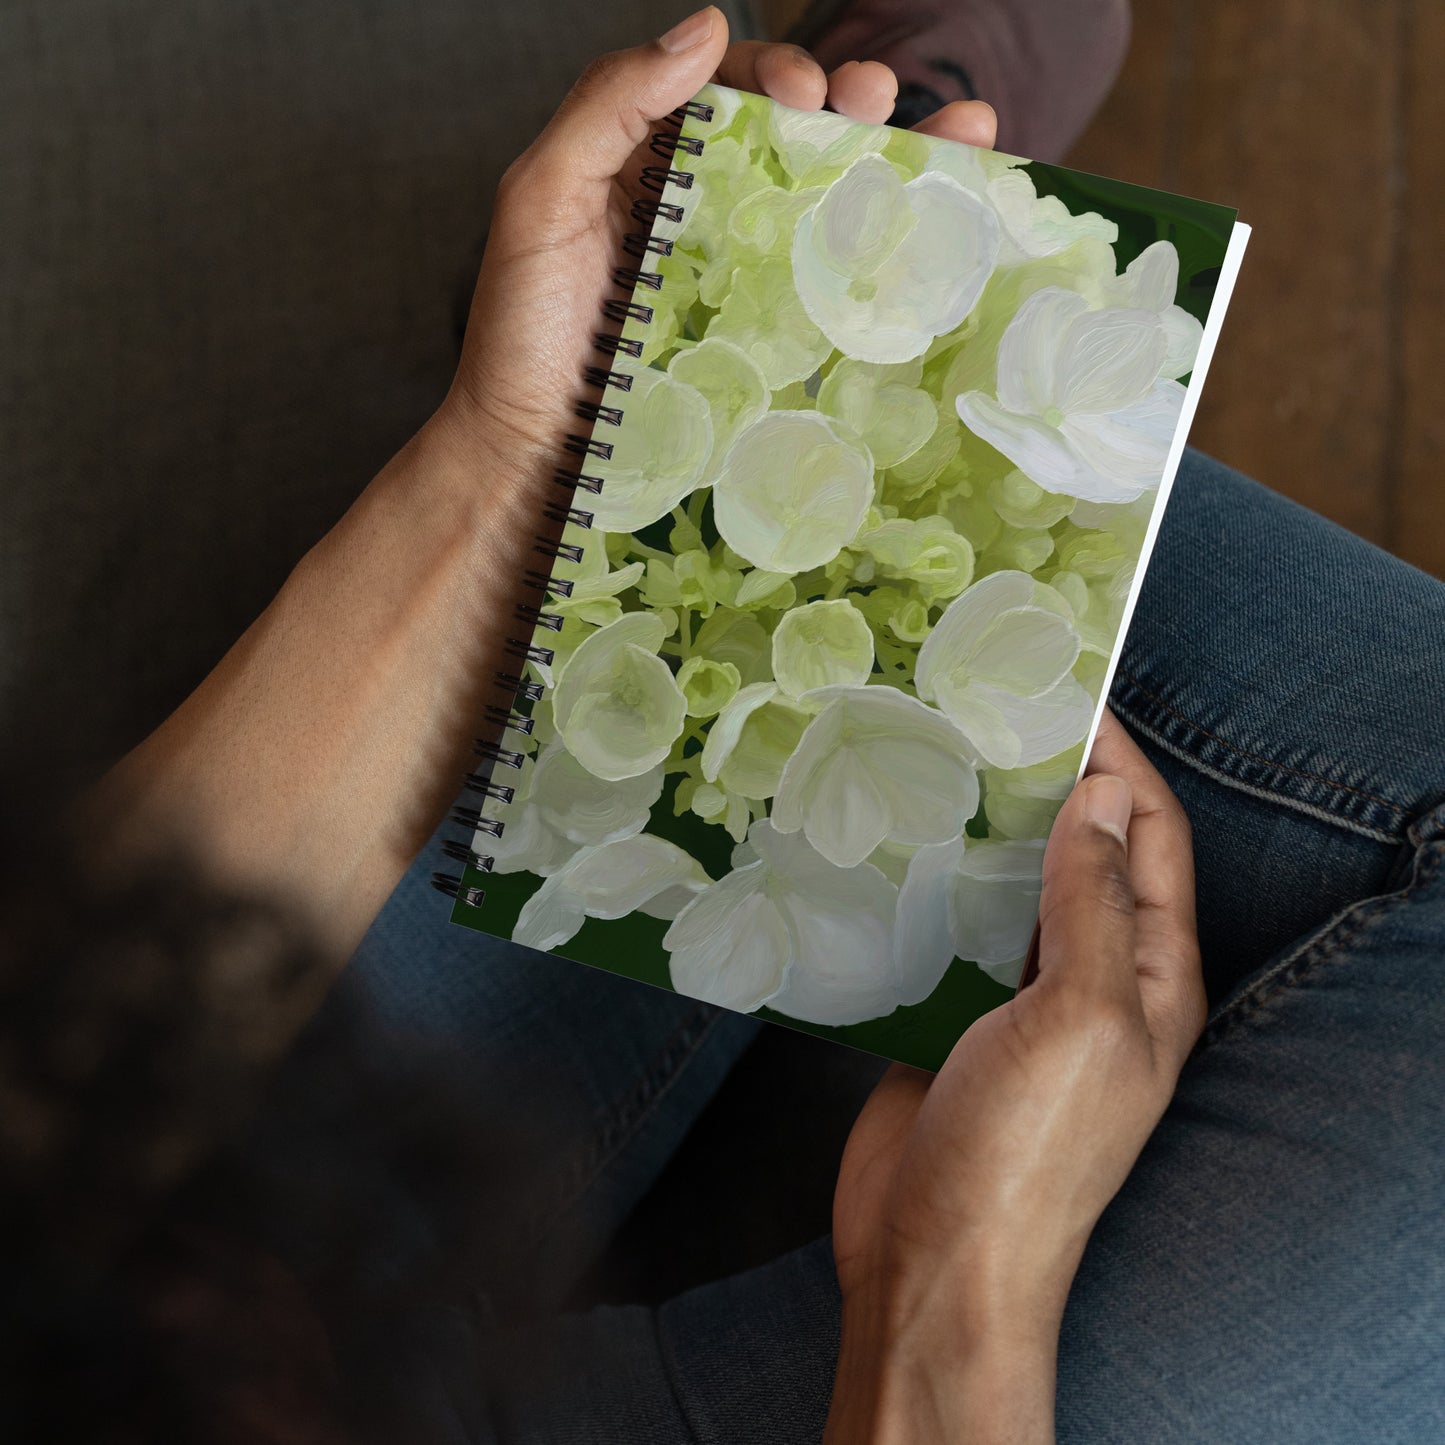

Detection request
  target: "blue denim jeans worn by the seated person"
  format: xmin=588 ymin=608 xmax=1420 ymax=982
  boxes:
xmin=319 ymin=454 xmax=1445 ymax=1445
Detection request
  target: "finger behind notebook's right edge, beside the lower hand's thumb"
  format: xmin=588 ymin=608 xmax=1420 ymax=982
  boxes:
xmin=1085 ymin=709 xmax=1205 ymax=1053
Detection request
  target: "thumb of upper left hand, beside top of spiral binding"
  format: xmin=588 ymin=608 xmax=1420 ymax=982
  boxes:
xmin=523 ymin=6 xmax=727 ymax=207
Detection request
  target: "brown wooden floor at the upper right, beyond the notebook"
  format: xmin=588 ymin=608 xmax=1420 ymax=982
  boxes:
xmin=762 ymin=0 xmax=1445 ymax=577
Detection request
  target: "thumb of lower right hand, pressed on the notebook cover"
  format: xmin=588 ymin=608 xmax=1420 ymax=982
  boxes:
xmin=1036 ymin=773 xmax=1142 ymax=1022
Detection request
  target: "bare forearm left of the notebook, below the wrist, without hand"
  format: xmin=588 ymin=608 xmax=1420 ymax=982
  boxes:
xmin=76 ymin=416 xmax=539 ymax=962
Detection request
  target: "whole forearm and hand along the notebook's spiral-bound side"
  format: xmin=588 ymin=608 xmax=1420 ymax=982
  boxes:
xmin=77 ymin=7 xmax=994 ymax=1051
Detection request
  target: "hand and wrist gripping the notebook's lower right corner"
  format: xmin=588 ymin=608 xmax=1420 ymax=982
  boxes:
xmin=828 ymin=712 xmax=1205 ymax=1445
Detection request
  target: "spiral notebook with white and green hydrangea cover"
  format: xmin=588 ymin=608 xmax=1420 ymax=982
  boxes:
xmin=435 ymin=85 xmax=1248 ymax=1068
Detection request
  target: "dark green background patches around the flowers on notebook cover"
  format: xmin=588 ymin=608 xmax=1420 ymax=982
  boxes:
xmin=451 ymin=162 xmax=1237 ymax=1069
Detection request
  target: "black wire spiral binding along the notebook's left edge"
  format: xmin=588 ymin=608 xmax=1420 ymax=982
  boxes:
xmin=432 ymin=100 xmax=712 ymax=907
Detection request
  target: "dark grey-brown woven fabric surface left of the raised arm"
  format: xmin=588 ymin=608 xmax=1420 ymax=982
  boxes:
xmin=0 ymin=0 xmax=736 ymax=803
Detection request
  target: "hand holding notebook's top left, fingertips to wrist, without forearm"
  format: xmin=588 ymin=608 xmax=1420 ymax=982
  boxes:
xmin=421 ymin=6 xmax=996 ymax=497
